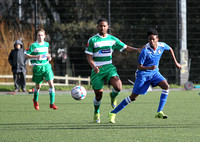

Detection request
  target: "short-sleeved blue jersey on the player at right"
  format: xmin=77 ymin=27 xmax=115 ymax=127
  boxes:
xmin=136 ymin=42 xmax=171 ymax=76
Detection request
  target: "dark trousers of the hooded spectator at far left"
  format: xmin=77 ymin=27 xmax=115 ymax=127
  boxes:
xmin=13 ymin=72 xmax=26 ymax=90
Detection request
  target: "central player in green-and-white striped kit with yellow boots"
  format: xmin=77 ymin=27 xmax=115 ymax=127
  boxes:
xmin=85 ymin=18 xmax=140 ymax=123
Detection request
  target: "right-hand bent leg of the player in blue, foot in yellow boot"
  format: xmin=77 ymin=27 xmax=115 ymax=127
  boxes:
xmin=152 ymin=73 xmax=169 ymax=119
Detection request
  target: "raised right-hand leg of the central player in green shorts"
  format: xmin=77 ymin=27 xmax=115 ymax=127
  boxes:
xmin=110 ymin=76 xmax=122 ymax=108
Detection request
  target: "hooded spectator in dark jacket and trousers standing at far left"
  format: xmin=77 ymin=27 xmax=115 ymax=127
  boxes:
xmin=8 ymin=40 xmax=27 ymax=92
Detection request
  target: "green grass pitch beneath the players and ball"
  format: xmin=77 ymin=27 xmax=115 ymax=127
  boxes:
xmin=0 ymin=90 xmax=200 ymax=142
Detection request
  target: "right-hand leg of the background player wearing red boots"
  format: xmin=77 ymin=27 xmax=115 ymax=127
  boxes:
xmin=47 ymin=80 xmax=58 ymax=109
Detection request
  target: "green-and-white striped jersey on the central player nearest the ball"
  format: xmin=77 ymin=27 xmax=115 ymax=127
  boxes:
xmin=85 ymin=34 xmax=127 ymax=66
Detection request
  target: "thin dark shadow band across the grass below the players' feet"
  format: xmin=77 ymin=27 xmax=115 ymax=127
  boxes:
xmin=0 ymin=123 xmax=200 ymax=130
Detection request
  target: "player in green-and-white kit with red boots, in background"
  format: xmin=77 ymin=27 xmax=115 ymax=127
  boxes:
xmin=25 ymin=29 xmax=58 ymax=110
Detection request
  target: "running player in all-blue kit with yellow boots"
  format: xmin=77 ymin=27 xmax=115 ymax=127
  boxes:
xmin=109 ymin=28 xmax=181 ymax=123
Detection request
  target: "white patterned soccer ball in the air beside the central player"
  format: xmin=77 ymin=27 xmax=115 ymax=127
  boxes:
xmin=71 ymin=86 xmax=86 ymax=100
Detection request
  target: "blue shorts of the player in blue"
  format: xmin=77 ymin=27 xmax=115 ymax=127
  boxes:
xmin=132 ymin=72 xmax=166 ymax=95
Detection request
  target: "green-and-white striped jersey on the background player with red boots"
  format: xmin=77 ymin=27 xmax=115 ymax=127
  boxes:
xmin=25 ymin=41 xmax=49 ymax=66
